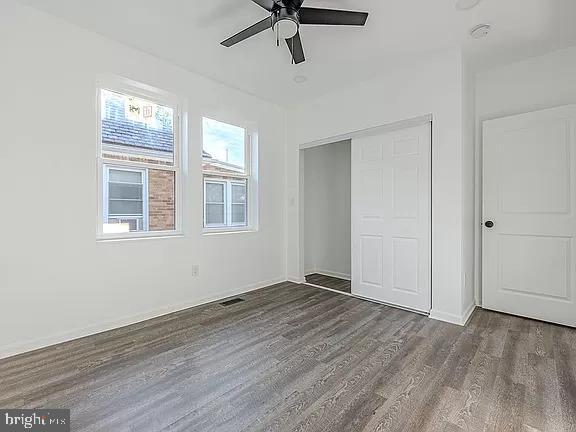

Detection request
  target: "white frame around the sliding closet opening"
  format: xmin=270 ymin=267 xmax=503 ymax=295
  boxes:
xmin=298 ymin=114 xmax=434 ymax=315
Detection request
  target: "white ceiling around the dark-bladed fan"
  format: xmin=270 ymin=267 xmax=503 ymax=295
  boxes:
xmin=21 ymin=0 xmax=576 ymax=104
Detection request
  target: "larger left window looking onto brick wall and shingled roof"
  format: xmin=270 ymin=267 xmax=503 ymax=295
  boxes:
xmin=98 ymin=85 xmax=179 ymax=238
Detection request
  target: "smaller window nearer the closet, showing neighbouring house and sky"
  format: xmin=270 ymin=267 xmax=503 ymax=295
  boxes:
xmin=202 ymin=118 xmax=253 ymax=231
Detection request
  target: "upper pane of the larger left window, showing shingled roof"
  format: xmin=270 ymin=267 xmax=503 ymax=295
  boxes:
xmin=101 ymin=90 xmax=174 ymax=164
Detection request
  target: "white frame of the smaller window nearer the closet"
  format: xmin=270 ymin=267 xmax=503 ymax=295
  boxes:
xmin=200 ymin=115 xmax=258 ymax=234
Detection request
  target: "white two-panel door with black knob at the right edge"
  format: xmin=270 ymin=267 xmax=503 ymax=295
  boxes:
xmin=482 ymin=106 xmax=576 ymax=326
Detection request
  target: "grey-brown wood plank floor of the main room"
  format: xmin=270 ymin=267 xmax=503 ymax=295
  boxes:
xmin=0 ymin=283 xmax=576 ymax=432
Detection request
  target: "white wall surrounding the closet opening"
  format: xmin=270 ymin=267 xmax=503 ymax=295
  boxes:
xmin=287 ymin=52 xmax=473 ymax=322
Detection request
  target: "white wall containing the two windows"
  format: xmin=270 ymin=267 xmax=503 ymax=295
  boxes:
xmin=0 ymin=1 xmax=286 ymax=356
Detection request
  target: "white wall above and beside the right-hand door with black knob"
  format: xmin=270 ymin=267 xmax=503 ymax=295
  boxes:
xmin=476 ymin=47 xmax=576 ymax=304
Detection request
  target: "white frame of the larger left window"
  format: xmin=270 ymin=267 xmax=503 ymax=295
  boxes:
xmin=95 ymin=76 xmax=183 ymax=241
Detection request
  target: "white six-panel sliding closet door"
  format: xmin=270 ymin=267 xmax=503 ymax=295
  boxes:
xmin=352 ymin=124 xmax=431 ymax=312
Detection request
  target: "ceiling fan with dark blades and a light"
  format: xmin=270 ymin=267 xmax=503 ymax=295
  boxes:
xmin=222 ymin=0 xmax=368 ymax=64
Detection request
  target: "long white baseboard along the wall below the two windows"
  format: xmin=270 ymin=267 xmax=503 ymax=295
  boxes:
xmin=0 ymin=277 xmax=286 ymax=359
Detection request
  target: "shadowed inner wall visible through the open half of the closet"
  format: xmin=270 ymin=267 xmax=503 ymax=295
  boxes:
xmin=303 ymin=141 xmax=352 ymax=278
